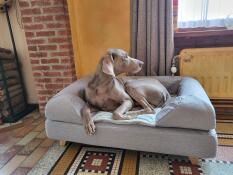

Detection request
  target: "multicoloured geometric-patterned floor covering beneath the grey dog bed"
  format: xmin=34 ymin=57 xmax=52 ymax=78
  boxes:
xmin=29 ymin=120 xmax=233 ymax=175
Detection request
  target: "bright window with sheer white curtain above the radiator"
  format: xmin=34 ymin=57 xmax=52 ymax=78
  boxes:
xmin=178 ymin=0 xmax=233 ymax=29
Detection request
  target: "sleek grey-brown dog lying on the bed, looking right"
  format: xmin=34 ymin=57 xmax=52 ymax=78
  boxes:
xmin=81 ymin=49 xmax=170 ymax=135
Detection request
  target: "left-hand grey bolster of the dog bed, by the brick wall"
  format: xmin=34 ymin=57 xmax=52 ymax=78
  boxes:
xmin=45 ymin=77 xmax=90 ymax=124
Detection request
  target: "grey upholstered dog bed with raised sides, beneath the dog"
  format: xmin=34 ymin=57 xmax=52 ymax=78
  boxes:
xmin=45 ymin=76 xmax=217 ymax=158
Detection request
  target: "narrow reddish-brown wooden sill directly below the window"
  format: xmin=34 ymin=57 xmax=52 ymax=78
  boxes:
xmin=174 ymin=29 xmax=233 ymax=38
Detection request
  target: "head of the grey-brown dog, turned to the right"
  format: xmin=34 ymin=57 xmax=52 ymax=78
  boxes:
xmin=102 ymin=49 xmax=144 ymax=76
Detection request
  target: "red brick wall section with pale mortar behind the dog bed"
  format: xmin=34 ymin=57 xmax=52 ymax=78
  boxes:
xmin=19 ymin=0 xmax=76 ymax=115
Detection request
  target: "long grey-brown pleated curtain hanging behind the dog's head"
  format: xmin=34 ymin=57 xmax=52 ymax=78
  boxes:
xmin=131 ymin=0 xmax=174 ymax=76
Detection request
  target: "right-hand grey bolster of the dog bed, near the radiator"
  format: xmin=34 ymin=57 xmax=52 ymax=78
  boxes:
xmin=156 ymin=77 xmax=216 ymax=130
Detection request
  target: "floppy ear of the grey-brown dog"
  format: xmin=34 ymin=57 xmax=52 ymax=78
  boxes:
xmin=102 ymin=54 xmax=115 ymax=77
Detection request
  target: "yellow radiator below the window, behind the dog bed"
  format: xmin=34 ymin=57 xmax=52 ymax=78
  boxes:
xmin=179 ymin=47 xmax=233 ymax=100
